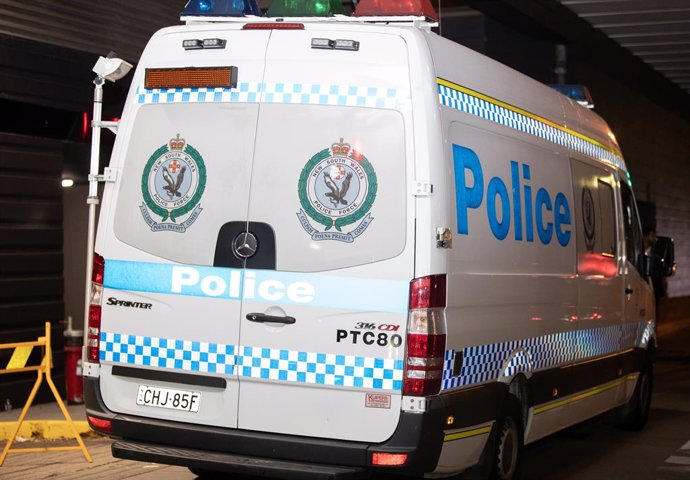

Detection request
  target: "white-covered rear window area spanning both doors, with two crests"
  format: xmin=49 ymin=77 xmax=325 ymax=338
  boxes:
xmin=114 ymin=103 xmax=407 ymax=271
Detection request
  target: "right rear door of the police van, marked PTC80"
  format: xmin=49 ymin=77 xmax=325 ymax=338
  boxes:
xmin=238 ymin=30 xmax=414 ymax=442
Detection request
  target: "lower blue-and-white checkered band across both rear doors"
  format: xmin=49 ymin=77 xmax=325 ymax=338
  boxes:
xmin=100 ymin=332 xmax=404 ymax=391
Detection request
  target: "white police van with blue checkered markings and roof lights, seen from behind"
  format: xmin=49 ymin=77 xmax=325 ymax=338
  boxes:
xmin=84 ymin=0 xmax=672 ymax=479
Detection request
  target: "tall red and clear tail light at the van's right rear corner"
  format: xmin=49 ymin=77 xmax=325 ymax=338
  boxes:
xmin=403 ymin=275 xmax=446 ymax=395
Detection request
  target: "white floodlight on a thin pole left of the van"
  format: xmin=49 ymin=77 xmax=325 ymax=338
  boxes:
xmin=82 ymin=52 xmax=132 ymax=365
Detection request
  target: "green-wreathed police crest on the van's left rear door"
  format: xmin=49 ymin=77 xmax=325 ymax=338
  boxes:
xmin=139 ymin=133 xmax=206 ymax=233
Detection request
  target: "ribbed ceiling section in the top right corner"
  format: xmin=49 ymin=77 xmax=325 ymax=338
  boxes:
xmin=558 ymin=0 xmax=690 ymax=94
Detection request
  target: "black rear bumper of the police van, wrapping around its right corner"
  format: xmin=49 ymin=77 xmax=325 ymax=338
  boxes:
xmin=84 ymin=377 xmax=496 ymax=479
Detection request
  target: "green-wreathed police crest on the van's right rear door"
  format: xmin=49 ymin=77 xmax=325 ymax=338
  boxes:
xmin=297 ymin=138 xmax=378 ymax=243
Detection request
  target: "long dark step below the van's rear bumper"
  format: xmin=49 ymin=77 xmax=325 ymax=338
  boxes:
xmin=112 ymin=441 xmax=369 ymax=480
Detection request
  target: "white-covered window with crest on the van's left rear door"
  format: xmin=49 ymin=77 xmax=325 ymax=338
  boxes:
xmin=114 ymin=103 xmax=258 ymax=265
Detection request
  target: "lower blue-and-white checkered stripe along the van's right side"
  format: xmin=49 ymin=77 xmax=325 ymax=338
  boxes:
xmin=443 ymin=322 xmax=654 ymax=389
